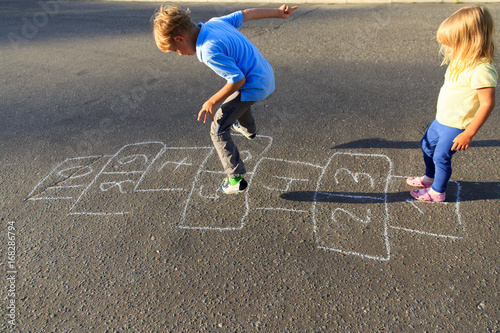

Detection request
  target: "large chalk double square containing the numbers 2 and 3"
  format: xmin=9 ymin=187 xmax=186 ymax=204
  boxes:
xmin=313 ymin=153 xmax=392 ymax=260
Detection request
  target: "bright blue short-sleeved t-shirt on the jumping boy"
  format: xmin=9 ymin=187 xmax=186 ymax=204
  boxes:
xmin=196 ymin=11 xmax=275 ymax=101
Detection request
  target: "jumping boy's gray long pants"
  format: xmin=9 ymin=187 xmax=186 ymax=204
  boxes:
xmin=210 ymin=91 xmax=256 ymax=178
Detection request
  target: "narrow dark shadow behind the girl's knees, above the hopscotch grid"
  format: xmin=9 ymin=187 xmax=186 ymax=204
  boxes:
xmin=331 ymin=138 xmax=500 ymax=149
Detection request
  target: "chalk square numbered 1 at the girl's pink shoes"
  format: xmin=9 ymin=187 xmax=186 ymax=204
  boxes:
xmin=388 ymin=177 xmax=465 ymax=238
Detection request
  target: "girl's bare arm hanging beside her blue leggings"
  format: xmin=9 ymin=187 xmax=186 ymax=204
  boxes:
xmin=451 ymin=87 xmax=495 ymax=150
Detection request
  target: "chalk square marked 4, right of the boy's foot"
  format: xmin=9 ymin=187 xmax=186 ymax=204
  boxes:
xmin=249 ymin=157 xmax=323 ymax=213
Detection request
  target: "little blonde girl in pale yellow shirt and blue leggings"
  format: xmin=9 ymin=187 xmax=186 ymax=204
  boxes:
xmin=406 ymin=6 xmax=498 ymax=201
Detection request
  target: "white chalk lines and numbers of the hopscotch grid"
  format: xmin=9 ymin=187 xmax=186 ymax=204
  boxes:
xmin=26 ymin=135 xmax=467 ymax=261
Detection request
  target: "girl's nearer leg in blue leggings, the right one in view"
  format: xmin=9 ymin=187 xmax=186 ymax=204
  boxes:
xmin=431 ymin=123 xmax=464 ymax=193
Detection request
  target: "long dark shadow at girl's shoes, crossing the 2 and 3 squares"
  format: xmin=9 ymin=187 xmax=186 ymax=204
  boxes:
xmin=280 ymin=182 xmax=500 ymax=203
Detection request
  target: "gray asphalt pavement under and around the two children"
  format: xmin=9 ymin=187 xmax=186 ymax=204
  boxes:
xmin=0 ymin=0 xmax=500 ymax=333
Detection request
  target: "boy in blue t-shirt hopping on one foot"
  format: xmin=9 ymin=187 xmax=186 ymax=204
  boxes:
xmin=154 ymin=4 xmax=298 ymax=194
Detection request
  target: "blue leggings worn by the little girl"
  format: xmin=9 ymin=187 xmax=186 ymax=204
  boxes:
xmin=420 ymin=120 xmax=464 ymax=193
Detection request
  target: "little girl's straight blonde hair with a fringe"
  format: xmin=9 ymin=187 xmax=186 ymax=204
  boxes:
xmin=436 ymin=6 xmax=495 ymax=77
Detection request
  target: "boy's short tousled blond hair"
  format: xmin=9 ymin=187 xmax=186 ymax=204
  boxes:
xmin=153 ymin=4 xmax=196 ymax=52
